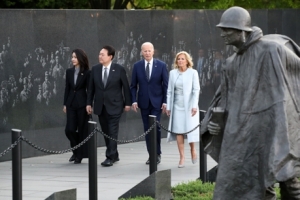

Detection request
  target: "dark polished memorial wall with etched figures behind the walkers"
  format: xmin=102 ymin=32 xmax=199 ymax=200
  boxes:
xmin=0 ymin=10 xmax=300 ymax=161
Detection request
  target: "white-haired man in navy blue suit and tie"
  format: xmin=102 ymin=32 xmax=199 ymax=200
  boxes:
xmin=130 ymin=42 xmax=168 ymax=164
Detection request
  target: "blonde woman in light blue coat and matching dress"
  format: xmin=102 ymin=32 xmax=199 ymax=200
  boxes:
xmin=166 ymin=51 xmax=200 ymax=168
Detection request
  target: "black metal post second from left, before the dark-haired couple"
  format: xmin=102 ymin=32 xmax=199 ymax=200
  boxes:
xmin=88 ymin=121 xmax=98 ymax=200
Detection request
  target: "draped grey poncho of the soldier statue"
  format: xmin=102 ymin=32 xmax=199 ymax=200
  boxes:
xmin=201 ymin=27 xmax=300 ymax=200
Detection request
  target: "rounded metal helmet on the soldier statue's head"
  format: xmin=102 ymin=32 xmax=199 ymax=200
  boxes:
xmin=217 ymin=6 xmax=252 ymax=31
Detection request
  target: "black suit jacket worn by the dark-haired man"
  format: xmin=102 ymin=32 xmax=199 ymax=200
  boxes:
xmin=87 ymin=63 xmax=131 ymax=115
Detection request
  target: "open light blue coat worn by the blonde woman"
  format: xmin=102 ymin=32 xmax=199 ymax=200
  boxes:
xmin=167 ymin=68 xmax=200 ymax=143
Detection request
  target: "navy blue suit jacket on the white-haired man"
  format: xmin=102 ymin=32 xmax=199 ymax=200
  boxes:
xmin=130 ymin=59 xmax=168 ymax=109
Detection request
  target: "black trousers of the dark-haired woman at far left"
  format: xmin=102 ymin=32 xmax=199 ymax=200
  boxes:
xmin=65 ymin=106 xmax=88 ymax=158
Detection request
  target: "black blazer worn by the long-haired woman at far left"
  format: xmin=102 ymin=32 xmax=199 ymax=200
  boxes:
xmin=64 ymin=67 xmax=90 ymax=108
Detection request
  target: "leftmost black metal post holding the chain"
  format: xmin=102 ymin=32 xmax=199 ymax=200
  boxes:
xmin=11 ymin=129 xmax=22 ymax=200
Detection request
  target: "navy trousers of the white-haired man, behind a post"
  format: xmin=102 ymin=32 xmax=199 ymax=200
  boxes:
xmin=141 ymin=102 xmax=161 ymax=155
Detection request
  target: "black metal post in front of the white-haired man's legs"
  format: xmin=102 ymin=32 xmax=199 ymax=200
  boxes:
xmin=149 ymin=115 xmax=157 ymax=175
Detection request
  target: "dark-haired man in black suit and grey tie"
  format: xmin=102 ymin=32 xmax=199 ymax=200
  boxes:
xmin=86 ymin=46 xmax=131 ymax=167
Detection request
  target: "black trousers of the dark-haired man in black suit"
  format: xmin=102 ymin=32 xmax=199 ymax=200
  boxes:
xmin=98 ymin=106 xmax=122 ymax=160
